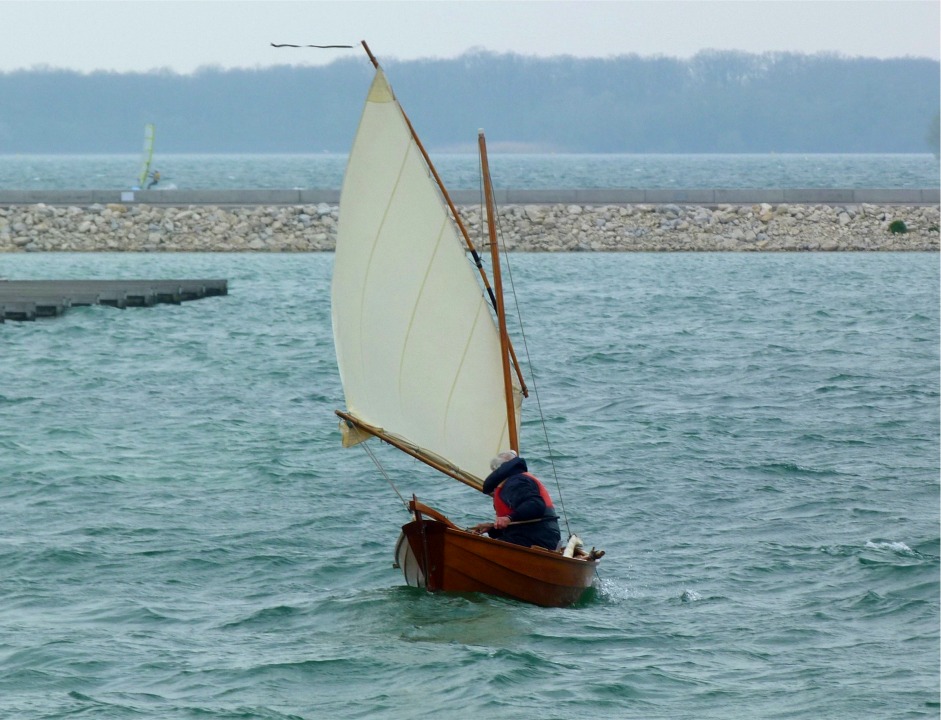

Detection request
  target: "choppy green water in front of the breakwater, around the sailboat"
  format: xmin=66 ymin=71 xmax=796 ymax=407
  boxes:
xmin=0 ymin=253 xmax=939 ymax=720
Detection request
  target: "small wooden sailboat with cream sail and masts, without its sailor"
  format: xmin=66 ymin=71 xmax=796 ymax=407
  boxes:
xmin=332 ymin=43 xmax=597 ymax=607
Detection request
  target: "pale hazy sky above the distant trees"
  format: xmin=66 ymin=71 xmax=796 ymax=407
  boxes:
xmin=0 ymin=0 xmax=941 ymax=73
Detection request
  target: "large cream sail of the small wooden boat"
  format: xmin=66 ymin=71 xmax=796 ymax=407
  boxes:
xmin=332 ymin=69 xmax=519 ymax=478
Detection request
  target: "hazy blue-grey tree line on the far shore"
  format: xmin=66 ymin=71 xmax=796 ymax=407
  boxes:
xmin=0 ymin=51 xmax=941 ymax=153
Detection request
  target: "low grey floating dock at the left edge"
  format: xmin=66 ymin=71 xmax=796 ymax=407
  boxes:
xmin=0 ymin=279 xmax=229 ymax=322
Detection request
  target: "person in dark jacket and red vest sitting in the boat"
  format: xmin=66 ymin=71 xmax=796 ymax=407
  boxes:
xmin=474 ymin=450 xmax=562 ymax=550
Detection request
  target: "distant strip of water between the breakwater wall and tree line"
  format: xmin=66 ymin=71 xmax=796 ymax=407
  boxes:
xmin=0 ymin=153 xmax=939 ymax=190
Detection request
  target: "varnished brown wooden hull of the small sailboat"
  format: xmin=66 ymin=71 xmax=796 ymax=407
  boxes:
xmin=396 ymin=518 xmax=597 ymax=607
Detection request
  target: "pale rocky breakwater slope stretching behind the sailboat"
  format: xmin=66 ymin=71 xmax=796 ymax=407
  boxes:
xmin=0 ymin=203 xmax=939 ymax=252
